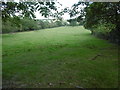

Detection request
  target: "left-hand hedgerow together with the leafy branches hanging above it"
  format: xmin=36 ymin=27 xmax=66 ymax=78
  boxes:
xmin=1 ymin=2 xmax=68 ymax=33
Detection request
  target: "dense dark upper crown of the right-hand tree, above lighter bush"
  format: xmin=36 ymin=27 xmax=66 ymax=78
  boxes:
xmin=85 ymin=2 xmax=120 ymax=28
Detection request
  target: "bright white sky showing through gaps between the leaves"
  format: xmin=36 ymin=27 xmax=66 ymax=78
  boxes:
xmin=35 ymin=0 xmax=79 ymax=20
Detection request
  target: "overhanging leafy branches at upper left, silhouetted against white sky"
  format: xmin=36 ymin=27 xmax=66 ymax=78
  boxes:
xmin=1 ymin=2 xmax=57 ymax=20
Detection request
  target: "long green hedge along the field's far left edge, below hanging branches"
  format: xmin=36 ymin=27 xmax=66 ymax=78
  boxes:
xmin=2 ymin=17 xmax=68 ymax=33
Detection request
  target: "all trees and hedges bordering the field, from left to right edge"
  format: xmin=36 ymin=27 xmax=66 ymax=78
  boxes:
xmin=1 ymin=2 xmax=120 ymax=43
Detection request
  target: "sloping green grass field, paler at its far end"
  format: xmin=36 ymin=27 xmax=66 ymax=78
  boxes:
xmin=2 ymin=26 xmax=118 ymax=88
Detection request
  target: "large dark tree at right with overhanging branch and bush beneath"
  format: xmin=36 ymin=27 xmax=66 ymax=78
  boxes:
xmin=70 ymin=2 xmax=120 ymax=42
